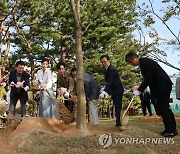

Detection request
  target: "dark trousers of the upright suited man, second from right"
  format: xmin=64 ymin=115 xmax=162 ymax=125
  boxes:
xmin=112 ymin=94 xmax=122 ymax=126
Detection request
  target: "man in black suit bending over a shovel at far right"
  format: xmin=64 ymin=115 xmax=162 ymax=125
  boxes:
xmin=125 ymin=52 xmax=178 ymax=137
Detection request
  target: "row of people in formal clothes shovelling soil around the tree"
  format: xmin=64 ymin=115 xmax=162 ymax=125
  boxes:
xmin=0 ymin=52 xmax=178 ymax=137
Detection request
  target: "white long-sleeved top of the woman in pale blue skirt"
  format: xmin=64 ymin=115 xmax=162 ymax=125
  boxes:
xmin=36 ymin=69 xmax=53 ymax=89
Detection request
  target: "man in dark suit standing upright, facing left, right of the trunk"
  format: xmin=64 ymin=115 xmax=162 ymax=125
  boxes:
xmin=100 ymin=55 xmax=124 ymax=130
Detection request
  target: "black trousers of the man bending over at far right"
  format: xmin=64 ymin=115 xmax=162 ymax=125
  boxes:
xmin=153 ymin=96 xmax=176 ymax=133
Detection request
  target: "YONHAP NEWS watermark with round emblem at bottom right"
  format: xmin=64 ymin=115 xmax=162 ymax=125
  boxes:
xmin=99 ymin=133 xmax=175 ymax=148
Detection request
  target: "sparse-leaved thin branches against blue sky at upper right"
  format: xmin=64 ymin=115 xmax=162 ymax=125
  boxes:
xmin=136 ymin=0 xmax=180 ymax=71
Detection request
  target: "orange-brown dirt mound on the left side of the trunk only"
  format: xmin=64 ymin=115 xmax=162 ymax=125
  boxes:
xmin=0 ymin=117 xmax=75 ymax=153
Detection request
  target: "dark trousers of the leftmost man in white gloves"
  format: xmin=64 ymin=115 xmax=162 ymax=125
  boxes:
xmin=9 ymin=94 xmax=27 ymax=117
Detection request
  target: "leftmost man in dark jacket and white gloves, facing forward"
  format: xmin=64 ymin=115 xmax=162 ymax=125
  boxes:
xmin=9 ymin=61 xmax=30 ymax=117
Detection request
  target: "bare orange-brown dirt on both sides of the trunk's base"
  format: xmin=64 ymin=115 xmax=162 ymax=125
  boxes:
xmin=0 ymin=117 xmax=126 ymax=153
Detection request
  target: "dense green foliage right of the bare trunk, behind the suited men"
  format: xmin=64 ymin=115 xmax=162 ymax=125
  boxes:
xmin=82 ymin=0 xmax=141 ymax=89
